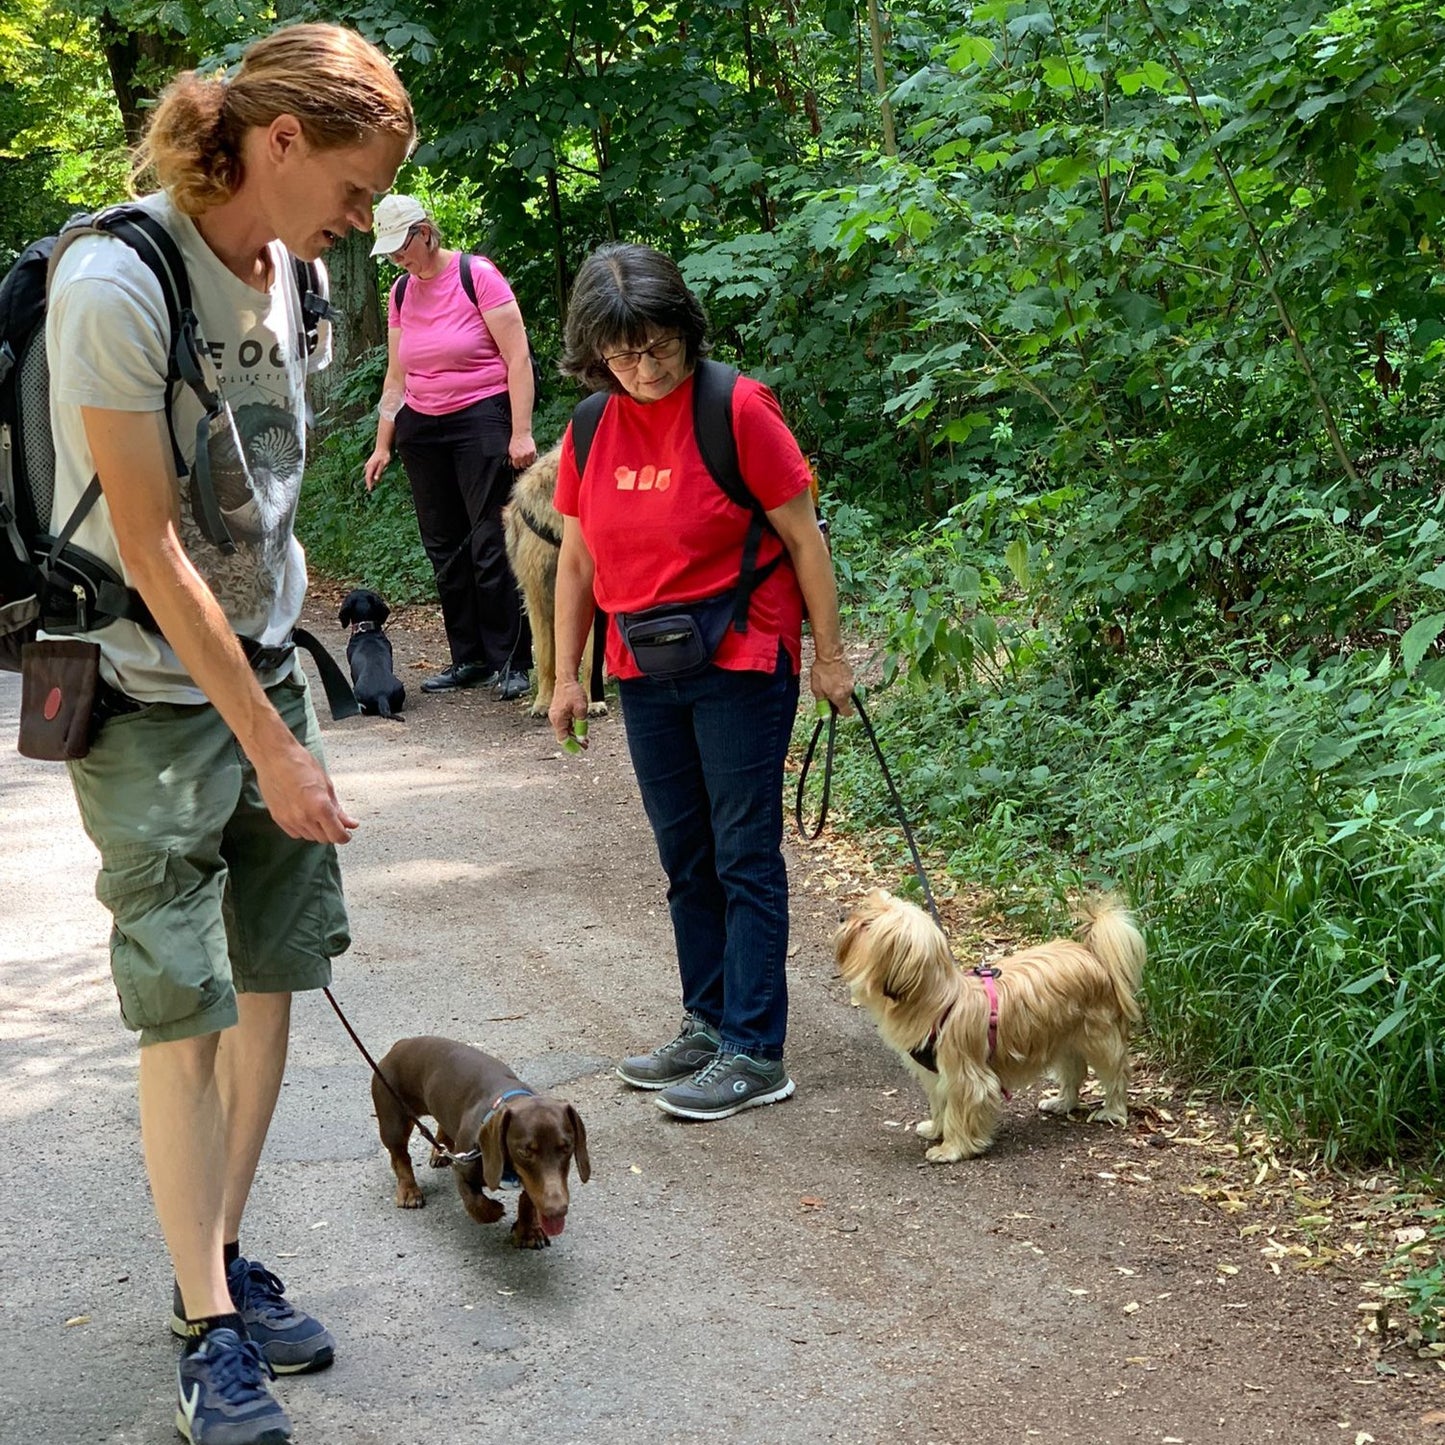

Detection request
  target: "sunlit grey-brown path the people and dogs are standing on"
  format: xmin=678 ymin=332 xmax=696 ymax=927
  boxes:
xmin=0 ymin=601 xmax=1445 ymax=1445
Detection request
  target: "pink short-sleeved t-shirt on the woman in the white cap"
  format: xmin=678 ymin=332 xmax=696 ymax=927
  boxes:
xmin=387 ymin=251 xmax=516 ymax=416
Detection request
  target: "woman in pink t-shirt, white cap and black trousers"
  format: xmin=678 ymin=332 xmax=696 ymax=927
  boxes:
xmin=364 ymin=195 xmax=536 ymax=698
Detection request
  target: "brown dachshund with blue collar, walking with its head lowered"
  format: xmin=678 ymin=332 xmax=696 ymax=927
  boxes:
xmin=371 ymin=1038 xmax=592 ymax=1250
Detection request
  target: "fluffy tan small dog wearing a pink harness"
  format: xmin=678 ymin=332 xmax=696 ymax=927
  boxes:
xmin=832 ymin=889 xmax=1144 ymax=1165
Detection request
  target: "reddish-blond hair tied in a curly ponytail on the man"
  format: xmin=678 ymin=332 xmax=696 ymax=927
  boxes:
xmin=133 ymin=25 xmax=416 ymax=215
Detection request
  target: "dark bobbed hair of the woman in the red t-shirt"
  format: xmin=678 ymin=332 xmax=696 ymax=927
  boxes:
xmin=561 ymin=243 xmax=708 ymax=392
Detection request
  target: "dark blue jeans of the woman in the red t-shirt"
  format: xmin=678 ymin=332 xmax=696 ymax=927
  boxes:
xmin=618 ymin=653 xmax=798 ymax=1059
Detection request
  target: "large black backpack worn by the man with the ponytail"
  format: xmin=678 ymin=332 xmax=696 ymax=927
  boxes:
xmin=0 ymin=205 xmax=331 ymax=672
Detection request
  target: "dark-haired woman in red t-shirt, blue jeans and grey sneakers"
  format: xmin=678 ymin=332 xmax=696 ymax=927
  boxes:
xmin=549 ymin=246 xmax=853 ymax=1118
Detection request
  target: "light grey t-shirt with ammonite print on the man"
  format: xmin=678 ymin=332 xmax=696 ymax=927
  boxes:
xmin=46 ymin=194 xmax=331 ymax=702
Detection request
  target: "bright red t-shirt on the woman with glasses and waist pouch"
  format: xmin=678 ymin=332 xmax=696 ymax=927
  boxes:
xmin=556 ymin=376 xmax=812 ymax=678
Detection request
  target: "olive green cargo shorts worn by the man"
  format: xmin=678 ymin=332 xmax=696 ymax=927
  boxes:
xmin=68 ymin=678 xmax=351 ymax=1045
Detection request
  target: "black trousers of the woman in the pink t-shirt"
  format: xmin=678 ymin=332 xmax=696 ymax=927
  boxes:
xmin=396 ymin=392 xmax=532 ymax=670
